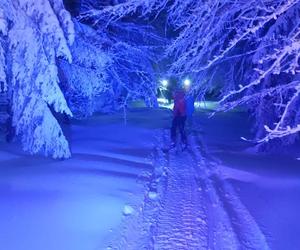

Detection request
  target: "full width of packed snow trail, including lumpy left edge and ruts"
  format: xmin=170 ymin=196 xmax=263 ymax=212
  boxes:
xmin=108 ymin=130 xmax=269 ymax=250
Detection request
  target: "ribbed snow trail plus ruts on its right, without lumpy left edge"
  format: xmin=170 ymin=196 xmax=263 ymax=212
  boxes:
xmin=154 ymin=131 xmax=268 ymax=249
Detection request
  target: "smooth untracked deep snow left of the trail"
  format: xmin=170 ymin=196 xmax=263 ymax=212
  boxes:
xmin=0 ymin=111 xmax=164 ymax=250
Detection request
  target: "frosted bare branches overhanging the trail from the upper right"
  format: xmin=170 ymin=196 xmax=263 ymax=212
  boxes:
xmin=84 ymin=0 xmax=300 ymax=146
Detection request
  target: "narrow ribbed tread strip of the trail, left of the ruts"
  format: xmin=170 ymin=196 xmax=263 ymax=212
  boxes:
xmin=154 ymin=131 xmax=208 ymax=249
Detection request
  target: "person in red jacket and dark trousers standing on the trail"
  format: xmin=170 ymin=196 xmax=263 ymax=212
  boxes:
xmin=171 ymin=89 xmax=187 ymax=146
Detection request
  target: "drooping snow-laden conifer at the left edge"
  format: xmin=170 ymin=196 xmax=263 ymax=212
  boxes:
xmin=0 ymin=0 xmax=74 ymax=158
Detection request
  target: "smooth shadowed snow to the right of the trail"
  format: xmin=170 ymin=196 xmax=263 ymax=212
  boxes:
xmin=202 ymin=113 xmax=300 ymax=250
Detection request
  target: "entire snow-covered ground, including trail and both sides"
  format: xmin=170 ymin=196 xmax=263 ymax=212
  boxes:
xmin=0 ymin=108 xmax=300 ymax=250
